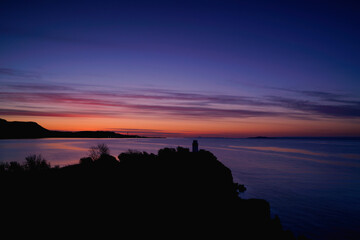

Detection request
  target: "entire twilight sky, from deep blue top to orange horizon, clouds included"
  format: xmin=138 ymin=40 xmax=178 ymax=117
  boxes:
xmin=0 ymin=0 xmax=360 ymax=137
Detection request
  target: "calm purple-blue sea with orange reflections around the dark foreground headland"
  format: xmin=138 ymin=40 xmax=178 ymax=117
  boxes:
xmin=0 ymin=138 xmax=360 ymax=240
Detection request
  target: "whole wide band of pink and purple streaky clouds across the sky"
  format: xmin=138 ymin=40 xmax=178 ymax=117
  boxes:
xmin=0 ymin=83 xmax=360 ymax=120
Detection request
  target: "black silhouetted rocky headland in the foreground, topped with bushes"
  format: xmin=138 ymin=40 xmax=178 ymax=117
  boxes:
xmin=0 ymin=143 xmax=306 ymax=239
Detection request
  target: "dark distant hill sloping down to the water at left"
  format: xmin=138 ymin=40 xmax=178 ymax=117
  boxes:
xmin=0 ymin=119 xmax=142 ymax=139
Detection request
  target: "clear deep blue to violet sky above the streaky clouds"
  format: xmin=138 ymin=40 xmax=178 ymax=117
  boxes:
xmin=0 ymin=0 xmax=360 ymax=135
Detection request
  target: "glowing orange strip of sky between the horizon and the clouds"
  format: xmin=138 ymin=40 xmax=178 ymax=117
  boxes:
xmin=5 ymin=117 xmax=360 ymax=137
